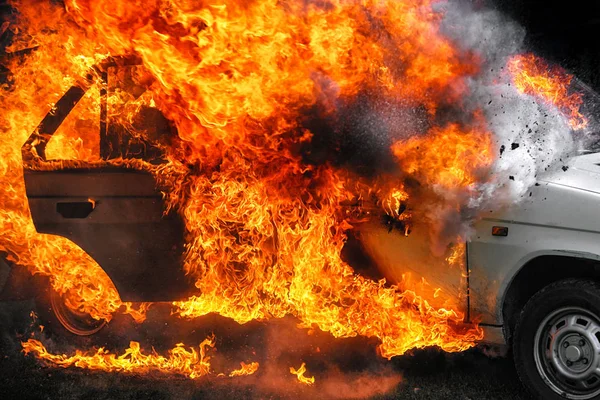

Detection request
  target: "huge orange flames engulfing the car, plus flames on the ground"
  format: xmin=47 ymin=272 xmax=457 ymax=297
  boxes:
xmin=0 ymin=0 xmax=510 ymax=379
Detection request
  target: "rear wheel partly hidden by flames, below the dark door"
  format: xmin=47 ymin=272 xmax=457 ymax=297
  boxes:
xmin=35 ymin=279 xmax=106 ymax=338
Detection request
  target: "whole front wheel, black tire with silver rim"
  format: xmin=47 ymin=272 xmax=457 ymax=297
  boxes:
xmin=513 ymin=279 xmax=600 ymax=400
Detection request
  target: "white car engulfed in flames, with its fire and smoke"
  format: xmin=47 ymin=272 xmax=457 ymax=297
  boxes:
xmin=0 ymin=0 xmax=600 ymax=399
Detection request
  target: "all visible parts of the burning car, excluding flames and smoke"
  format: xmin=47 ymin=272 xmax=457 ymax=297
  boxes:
xmin=0 ymin=59 xmax=600 ymax=399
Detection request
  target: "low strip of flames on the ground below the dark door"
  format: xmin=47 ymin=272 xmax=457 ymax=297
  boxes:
xmin=22 ymin=337 xmax=217 ymax=379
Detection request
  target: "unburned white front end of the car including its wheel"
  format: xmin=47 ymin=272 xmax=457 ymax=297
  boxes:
xmin=360 ymin=148 xmax=600 ymax=399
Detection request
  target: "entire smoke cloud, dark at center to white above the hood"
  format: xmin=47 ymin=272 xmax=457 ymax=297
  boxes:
xmin=308 ymin=0 xmax=585 ymax=254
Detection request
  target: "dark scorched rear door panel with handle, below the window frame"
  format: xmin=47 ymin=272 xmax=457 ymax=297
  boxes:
xmin=25 ymin=168 xmax=192 ymax=301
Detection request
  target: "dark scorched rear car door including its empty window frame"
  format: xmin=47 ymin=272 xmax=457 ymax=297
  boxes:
xmin=22 ymin=59 xmax=193 ymax=301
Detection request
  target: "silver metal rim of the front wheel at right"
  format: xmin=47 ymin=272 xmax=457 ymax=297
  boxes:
xmin=534 ymin=307 xmax=600 ymax=400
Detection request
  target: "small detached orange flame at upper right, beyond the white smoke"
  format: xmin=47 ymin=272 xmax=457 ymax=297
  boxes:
xmin=508 ymin=54 xmax=588 ymax=129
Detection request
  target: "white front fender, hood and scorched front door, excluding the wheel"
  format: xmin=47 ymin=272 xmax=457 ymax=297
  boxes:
xmin=361 ymin=153 xmax=600 ymax=345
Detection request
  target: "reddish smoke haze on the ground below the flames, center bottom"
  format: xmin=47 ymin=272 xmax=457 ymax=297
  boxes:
xmin=230 ymin=318 xmax=402 ymax=399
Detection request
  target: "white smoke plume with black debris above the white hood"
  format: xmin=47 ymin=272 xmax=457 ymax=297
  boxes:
xmin=442 ymin=1 xmax=577 ymax=215
